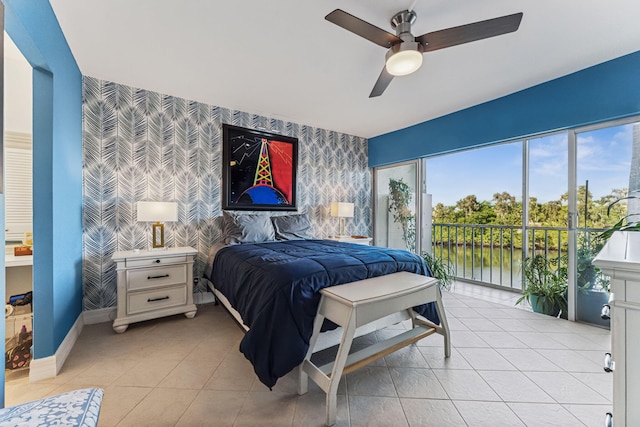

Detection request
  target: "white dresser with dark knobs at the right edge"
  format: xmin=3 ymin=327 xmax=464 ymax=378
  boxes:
xmin=593 ymin=232 xmax=640 ymax=427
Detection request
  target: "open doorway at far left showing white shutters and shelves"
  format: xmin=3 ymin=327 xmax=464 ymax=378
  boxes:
xmin=3 ymin=33 xmax=33 ymax=380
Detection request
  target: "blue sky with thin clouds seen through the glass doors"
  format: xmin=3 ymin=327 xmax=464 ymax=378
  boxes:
xmin=427 ymin=125 xmax=633 ymax=206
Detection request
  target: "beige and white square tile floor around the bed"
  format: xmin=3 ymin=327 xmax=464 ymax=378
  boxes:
xmin=5 ymin=283 xmax=612 ymax=427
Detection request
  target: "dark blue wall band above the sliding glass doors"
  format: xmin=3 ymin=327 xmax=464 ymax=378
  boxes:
xmin=369 ymin=51 xmax=640 ymax=167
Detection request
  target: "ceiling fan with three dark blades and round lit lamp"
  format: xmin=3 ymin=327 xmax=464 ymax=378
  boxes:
xmin=325 ymin=9 xmax=522 ymax=98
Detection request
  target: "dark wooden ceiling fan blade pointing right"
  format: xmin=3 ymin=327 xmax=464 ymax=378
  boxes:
xmin=416 ymin=12 xmax=522 ymax=52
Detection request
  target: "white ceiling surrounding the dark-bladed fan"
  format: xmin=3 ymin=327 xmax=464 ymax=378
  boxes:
xmin=50 ymin=0 xmax=640 ymax=137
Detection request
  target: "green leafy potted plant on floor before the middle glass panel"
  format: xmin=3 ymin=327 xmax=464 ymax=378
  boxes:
xmin=516 ymin=255 xmax=568 ymax=317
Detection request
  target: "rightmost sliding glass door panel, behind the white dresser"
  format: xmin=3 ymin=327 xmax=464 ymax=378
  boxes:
xmin=573 ymin=123 xmax=640 ymax=326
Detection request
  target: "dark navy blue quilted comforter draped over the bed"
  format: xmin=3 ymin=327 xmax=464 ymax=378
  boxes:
xmin=209 ymin=240 xmax=440 ymax=388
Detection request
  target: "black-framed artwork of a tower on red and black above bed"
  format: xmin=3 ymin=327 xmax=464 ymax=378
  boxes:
xmin=222 ymin=124 xmax=298 ymax=211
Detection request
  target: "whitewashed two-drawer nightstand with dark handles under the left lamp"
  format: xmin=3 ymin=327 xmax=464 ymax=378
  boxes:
xmin=111 ymin=246 xmax=198 ymax=333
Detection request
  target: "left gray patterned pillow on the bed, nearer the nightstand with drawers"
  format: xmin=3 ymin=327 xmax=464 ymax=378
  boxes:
xmin=222 ymin=211 xmax=276 ymax=245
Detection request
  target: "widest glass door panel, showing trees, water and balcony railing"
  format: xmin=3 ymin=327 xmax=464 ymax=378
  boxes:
xmin=425 ymin=141 xmax=523 ymax=290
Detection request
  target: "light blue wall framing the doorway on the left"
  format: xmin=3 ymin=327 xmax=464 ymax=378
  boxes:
xmin=3 ymin=0 xmax=82 ymax=358
